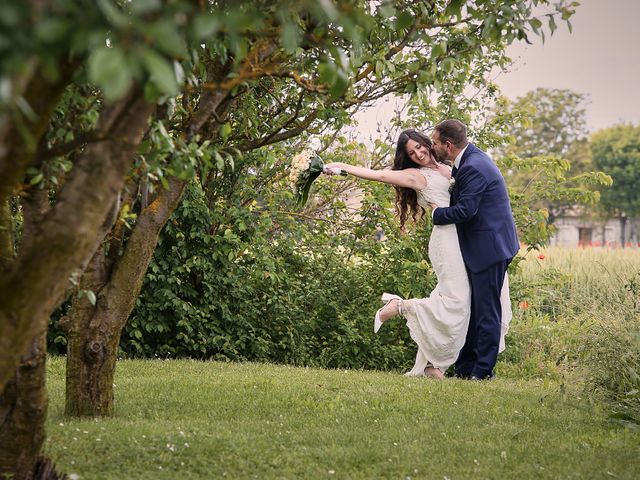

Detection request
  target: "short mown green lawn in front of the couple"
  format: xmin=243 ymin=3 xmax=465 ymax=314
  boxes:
xmin=45 ymin=358 xmax=640 ymax=480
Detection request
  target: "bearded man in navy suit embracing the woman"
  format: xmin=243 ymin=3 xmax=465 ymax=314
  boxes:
xmin=432 ymin=120 xmax=519 ymax=380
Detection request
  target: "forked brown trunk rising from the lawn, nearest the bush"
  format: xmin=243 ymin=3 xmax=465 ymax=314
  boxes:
xmin=65 ymin=178 xmax=185 ymax=417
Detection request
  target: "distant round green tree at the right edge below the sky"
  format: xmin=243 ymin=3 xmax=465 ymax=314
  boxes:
xmin=591 ymin=124 xmax=640 ymax=247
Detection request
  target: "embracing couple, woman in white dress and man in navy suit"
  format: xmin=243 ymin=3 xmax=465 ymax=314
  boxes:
xmin=325 ymin=120 xmax=519 ymax=380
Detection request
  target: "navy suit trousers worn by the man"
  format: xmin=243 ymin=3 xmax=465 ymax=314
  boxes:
xmin=455 ymin=260 xmax=511 ymax=379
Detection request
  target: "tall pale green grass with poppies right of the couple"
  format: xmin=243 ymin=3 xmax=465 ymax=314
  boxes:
xmin=504 ymin=247 xmax=640 ymax=426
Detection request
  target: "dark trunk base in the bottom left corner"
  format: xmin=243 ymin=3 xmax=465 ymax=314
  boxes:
xmin=0 ymin=334 xmax=48 ymax=480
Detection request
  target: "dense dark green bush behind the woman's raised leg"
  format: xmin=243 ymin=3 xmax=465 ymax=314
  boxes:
xmin=121 ymin=183 xmax=435 ymax=369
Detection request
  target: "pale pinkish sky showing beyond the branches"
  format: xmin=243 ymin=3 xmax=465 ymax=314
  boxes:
xmin=356 ymin=0 xmax=640 ymax=139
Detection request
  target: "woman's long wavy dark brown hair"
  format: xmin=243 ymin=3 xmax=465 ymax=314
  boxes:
xmin=392 ymin=128 xmax=436 ymax=229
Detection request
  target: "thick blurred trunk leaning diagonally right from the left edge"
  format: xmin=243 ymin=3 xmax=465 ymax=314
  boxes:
xmin=0 ymin=90 xmax=154 ymax=390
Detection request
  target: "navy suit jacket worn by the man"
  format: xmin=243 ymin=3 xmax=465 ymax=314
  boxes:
xmin=433 ymin=143 xmax=519 ymax=273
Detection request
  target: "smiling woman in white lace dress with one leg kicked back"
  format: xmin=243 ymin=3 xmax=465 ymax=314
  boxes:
xmin=325 ymin=129 xmax=511 ymax=379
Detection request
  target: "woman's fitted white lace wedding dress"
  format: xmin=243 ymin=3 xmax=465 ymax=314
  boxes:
xmin=402 ymin=168 xmax=512 ymax=376
